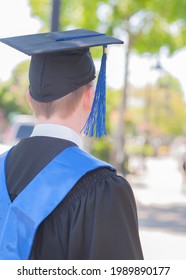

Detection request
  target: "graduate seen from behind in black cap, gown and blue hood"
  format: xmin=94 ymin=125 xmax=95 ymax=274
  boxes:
xmin=0 ymin=29 xmax=143 ymax=260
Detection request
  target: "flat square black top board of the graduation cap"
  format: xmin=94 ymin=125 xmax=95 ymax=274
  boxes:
xmin=0 ymin=29 xmax=123 ymax=55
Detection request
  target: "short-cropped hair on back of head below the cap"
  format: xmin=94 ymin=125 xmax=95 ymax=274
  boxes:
xmin=30 ymin=82 xmax=93 ymax=119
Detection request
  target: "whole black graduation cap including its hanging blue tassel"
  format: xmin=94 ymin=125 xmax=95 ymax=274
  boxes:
xmin=0 ymin=29 xmax=123 ymax=136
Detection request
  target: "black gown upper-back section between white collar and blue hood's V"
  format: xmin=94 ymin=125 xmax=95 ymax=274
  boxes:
xmin=6 ymin=136 xmax=75 ymax=200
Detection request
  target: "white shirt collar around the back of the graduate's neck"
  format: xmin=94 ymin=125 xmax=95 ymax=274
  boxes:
xmin=30 ymin=124 xmax=82 ymax=149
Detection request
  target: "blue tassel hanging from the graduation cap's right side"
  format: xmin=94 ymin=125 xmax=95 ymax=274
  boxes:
xmin=83 ymin=46 xmax=107 ymax=138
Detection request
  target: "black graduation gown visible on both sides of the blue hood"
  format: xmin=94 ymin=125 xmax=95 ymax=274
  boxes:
xmin=6 ymin=136 xmax=143 ymax=260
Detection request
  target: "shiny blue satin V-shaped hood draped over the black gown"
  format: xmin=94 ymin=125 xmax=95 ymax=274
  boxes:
xmin=0 ymin=147 xmax=114 ymax=260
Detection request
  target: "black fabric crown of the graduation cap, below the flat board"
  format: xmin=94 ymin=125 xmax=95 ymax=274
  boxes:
xmin=29 ymin=49 xmax=96 ymax=102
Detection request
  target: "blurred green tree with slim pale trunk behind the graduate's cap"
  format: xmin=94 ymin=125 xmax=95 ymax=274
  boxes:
xmin=30 ymin=0 xmax=186 ymax=173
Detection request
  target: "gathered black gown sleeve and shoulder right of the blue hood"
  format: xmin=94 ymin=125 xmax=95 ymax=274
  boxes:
xmin=31 ymin=166 xmax=143 ymax=260
